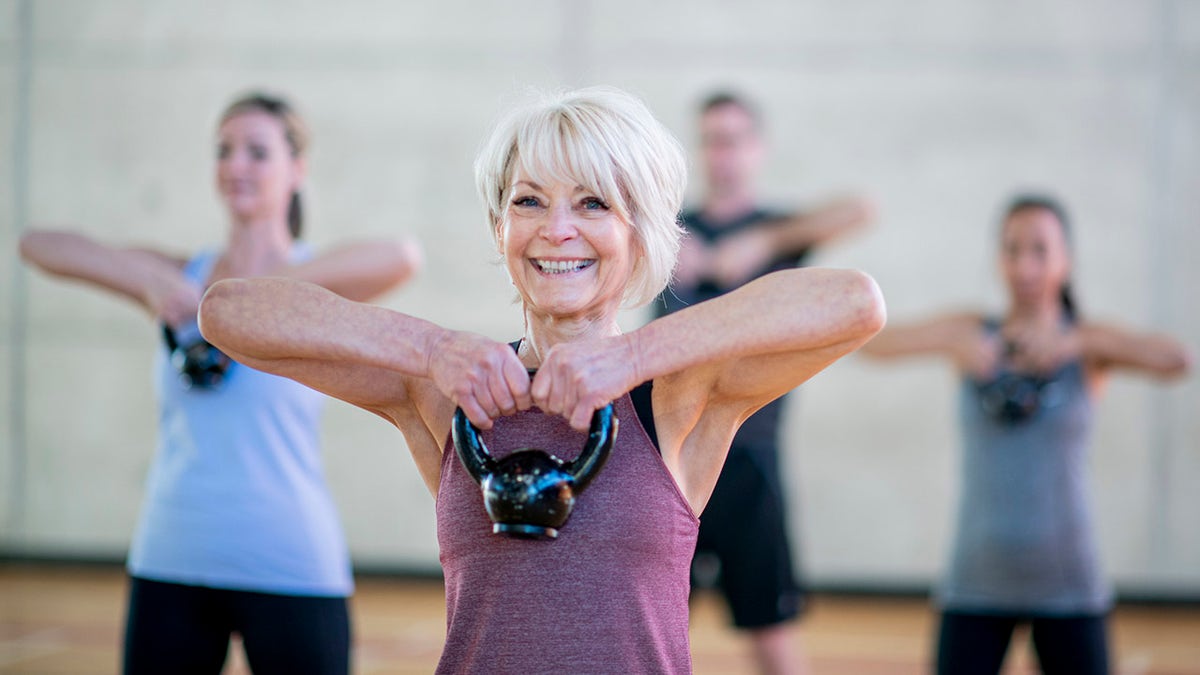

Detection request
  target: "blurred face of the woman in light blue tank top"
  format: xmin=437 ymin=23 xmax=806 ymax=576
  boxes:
xmin=217 ymin=110 xmax=304 ymax=220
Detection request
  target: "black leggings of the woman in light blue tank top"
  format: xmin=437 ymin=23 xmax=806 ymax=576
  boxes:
xmin=124 ymin=578 xmax=350 ymax=675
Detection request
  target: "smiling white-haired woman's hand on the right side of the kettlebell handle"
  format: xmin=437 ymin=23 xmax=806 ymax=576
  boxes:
xmin=530 ymin=335 xmax=640 ymax=431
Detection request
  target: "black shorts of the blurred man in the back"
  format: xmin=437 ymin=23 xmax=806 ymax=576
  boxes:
xmin=692 ymin=448 xmax=804 ymax=629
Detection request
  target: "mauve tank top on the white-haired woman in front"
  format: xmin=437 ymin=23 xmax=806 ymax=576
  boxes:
xmin=437 ymin=386 xmax=700 ymax=674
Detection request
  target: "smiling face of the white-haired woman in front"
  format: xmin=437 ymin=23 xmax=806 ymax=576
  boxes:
xmin=499 ymin=168 xmax=640 ymax=318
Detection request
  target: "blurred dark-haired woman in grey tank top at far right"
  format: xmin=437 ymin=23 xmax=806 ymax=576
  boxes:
xmin=863 ymin=196 xmax=1189 ymax=674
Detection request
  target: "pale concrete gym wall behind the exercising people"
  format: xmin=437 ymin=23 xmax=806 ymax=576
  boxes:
xmin=0 ymin=0 xmax=1200 ymax=595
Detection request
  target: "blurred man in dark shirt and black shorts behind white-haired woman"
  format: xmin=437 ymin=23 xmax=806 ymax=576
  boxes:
xmin=653 ymin=92 xmax=874 ymax=673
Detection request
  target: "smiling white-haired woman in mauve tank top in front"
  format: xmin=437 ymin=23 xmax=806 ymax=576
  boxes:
xmin=200 ymin=88 xmax=883 ymax=674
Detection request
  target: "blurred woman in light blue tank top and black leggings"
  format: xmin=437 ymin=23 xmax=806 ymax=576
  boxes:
xmin=22 ymin=94 xmax=419 ymax=675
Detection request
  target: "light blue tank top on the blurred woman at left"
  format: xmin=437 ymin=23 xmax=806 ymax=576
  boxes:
xmin=128 ymin=246 xmax=354 ymax=597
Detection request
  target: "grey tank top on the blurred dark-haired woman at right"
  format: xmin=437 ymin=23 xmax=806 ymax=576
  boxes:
xmin=936 ymin=322 xmax=1112 ymax=615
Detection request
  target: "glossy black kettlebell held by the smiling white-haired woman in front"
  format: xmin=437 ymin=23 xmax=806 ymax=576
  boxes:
xmin=451 ymin=381 xmax=618 ymax=539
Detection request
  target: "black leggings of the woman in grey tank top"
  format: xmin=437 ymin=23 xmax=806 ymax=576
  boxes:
xmin=937 ymin=611 xmax=1109 ymax=675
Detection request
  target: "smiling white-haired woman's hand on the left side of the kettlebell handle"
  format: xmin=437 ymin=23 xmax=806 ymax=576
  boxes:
xmin=428 ymin=330 xmax=533 ymax=429
